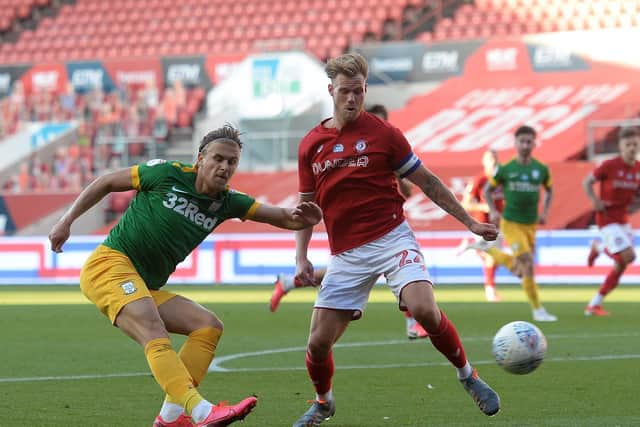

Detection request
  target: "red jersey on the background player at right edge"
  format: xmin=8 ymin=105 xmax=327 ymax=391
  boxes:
xmin=593 ymin=156 xmax=640 ymax=227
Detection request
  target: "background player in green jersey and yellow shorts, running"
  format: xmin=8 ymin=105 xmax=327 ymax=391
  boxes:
xmin=478 ymin=126 xmax=558 ymax=322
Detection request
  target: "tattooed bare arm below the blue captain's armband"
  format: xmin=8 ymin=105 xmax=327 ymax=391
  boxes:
xmin=407 ymin=166 xmax=498 ymax=240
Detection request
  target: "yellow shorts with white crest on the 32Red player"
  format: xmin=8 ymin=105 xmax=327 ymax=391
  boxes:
xmin=80 ymin=245 xmax=177 ymax=324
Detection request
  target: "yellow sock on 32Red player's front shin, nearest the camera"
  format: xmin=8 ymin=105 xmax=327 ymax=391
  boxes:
xmin=144 ymin=338 xmax=204 ymax=414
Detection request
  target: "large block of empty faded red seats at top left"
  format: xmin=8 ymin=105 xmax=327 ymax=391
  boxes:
xmin=0 ymin=0 xmax=430 ymax=63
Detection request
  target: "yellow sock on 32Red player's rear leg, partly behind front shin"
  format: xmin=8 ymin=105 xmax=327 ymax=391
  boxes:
xmin=165 ymin=328 xmax=222 ymax=404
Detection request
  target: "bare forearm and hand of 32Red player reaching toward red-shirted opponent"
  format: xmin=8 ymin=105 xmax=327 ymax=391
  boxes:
xmin=251 ymin=202 xmax=322 ymax=230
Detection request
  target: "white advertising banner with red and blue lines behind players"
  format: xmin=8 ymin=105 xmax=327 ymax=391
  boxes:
xmin=0 ymin=230 xmax=640 ymax=285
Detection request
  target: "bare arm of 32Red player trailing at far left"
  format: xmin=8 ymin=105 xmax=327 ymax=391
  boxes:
xmin=49 ymin=168 xmax=133 ymax=253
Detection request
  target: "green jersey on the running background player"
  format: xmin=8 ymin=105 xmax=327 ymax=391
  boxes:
xmin=489 ymin=159 xmax=551 ymax=224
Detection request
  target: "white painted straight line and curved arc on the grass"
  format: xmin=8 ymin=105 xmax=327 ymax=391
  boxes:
xmin=0 ymin=332 xmax=640 ymax=384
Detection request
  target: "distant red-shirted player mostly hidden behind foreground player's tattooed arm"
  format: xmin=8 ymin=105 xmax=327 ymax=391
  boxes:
xmin=460 ymin=150 xmax=504 ymax=302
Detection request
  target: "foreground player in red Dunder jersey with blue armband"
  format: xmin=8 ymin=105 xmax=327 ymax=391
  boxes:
xmin=294 ymin=53 xmax=500 ymax=427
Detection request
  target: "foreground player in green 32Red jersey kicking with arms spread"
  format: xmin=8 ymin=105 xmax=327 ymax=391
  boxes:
xmin=49 ymin=125 xmax=322 ymax=427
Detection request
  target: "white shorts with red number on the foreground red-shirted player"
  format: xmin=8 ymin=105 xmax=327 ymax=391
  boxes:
xmin=314 ymin=221 xmax=431 ymax=318
